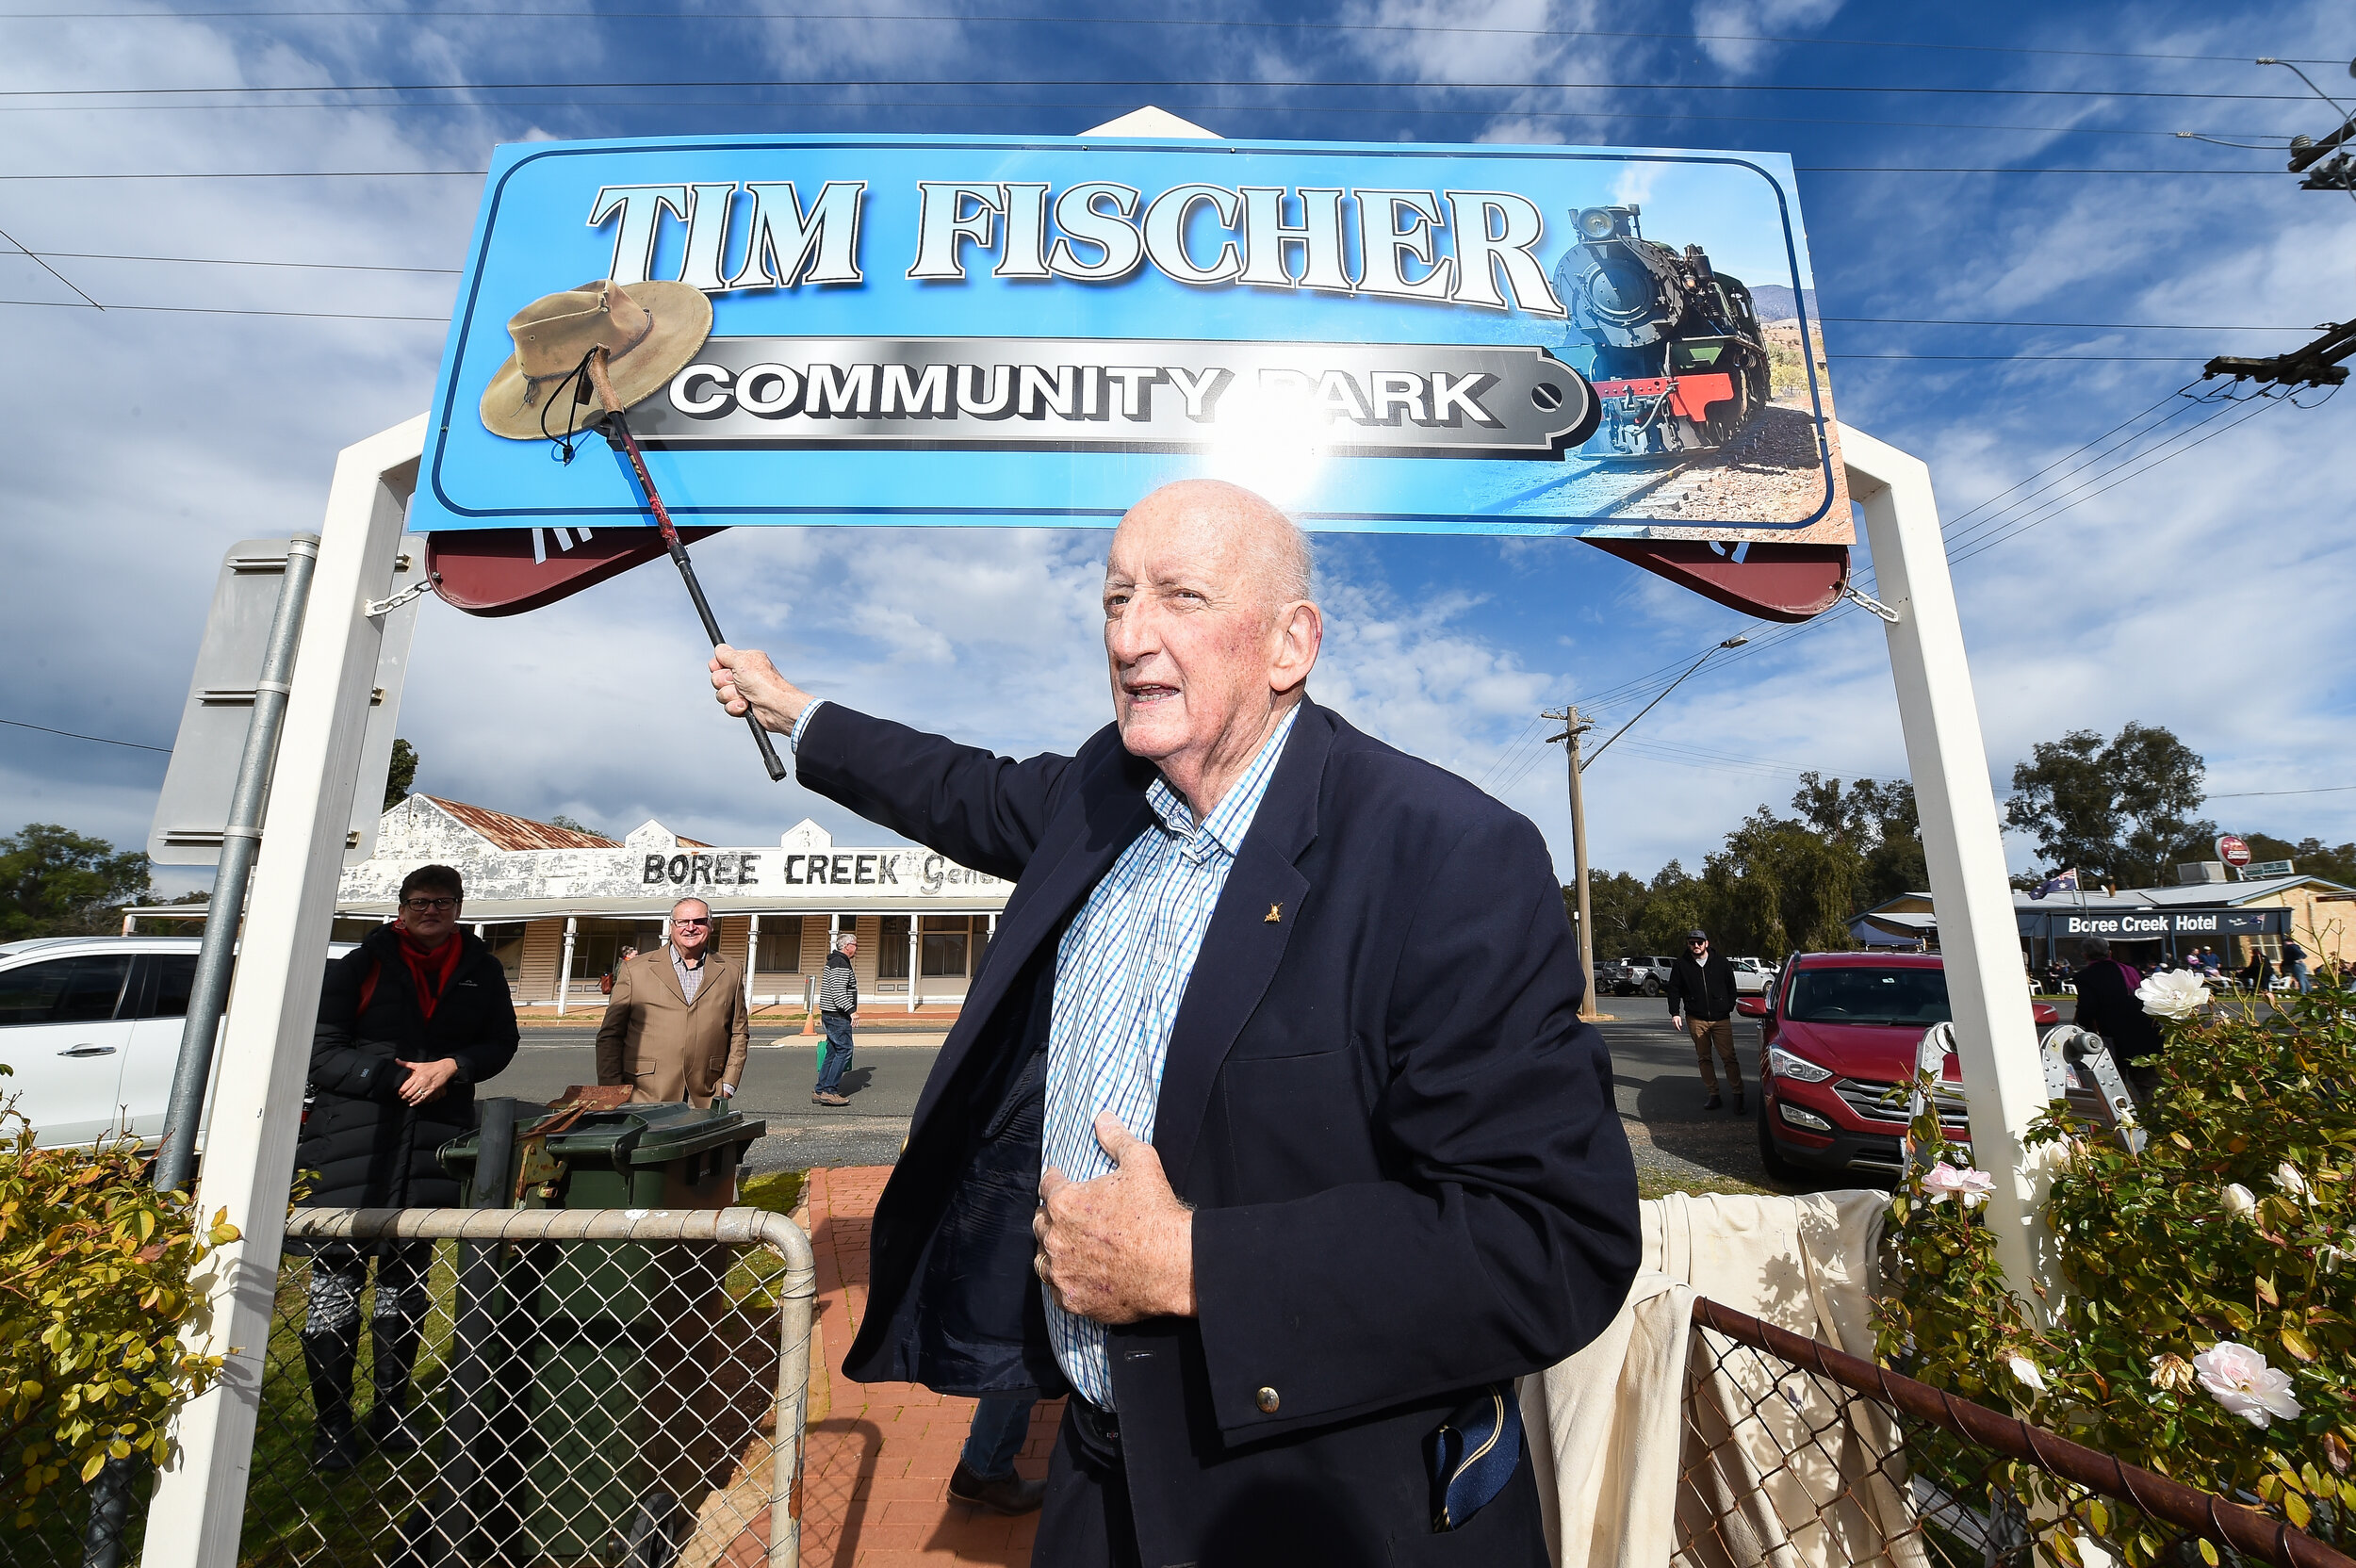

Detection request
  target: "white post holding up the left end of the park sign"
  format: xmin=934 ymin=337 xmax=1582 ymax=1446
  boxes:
xmin=141 ymin=415 xmax=427 ymax=1568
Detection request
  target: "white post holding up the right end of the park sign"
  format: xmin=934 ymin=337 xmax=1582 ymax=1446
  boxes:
xmin=1841 ymin=426 xmax=2059 ymax=1318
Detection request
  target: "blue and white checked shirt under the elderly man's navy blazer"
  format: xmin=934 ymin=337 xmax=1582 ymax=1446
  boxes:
xmin=1041 ymin=707 xmax=1301 ymax=1411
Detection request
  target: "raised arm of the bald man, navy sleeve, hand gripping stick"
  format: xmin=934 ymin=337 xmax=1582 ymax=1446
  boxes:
xmin=712 ymin=643 xmax=1072 ymax=880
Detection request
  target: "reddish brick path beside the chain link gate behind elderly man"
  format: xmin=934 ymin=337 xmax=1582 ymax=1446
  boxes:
xmin=801 ymin=1166 xmax=1063 ymax=1568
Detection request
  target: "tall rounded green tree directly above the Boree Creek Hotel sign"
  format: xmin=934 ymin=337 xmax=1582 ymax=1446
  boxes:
xmin=2005 ymin=723 xmax=2217 ymax=888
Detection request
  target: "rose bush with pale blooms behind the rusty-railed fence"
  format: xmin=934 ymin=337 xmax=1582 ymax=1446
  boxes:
xmin=1878 ymin=970 xmax=2356 ymax=1568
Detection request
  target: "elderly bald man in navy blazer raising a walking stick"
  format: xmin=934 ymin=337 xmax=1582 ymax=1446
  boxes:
xmin=712 ymin=481 xmax=1638 ymax=1568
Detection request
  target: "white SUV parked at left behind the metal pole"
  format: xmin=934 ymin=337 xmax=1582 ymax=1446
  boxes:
xmin=0 ymin=937 xmax=353 ymax=1147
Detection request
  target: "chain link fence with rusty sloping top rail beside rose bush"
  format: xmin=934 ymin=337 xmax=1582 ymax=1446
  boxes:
xmin=1676 ymin=1299 xmax=2356 ymax=1568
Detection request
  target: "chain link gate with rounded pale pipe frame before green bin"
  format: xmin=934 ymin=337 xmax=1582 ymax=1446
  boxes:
xmin=0 ymin=1208 xmax=815 ymax=1568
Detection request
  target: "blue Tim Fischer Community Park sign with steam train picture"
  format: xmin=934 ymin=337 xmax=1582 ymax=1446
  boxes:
xmin=410 ymin=137 xmax=1850 ymax=547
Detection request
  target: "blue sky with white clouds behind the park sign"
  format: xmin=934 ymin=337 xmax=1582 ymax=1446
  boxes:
xmin=13 ymin=0 xmax=2356 ymax=904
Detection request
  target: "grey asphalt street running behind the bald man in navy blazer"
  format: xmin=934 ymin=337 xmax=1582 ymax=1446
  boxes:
xmin=493 ymin=998 xmax=1809 ymax=1194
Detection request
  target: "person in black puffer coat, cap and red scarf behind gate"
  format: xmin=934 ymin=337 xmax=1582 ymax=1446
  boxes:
xmin=295 ymin=866 xmax=516 ymax=1472
